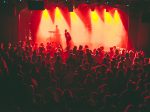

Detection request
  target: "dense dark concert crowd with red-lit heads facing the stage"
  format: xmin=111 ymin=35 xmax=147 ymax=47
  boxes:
xmin=0 ymin=42 xmax=150 ymax=112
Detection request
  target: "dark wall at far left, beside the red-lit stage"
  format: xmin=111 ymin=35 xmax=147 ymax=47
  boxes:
xmin=0 ymin=6 xmax=18 ymax=42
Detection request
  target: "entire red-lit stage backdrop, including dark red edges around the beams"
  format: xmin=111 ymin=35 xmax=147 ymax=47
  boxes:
xmin=19 ymin=5 xmax=128 ymax=50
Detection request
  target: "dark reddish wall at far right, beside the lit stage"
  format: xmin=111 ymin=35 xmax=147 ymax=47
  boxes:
xmin=128 ymin=9 xmax=150 ymax=56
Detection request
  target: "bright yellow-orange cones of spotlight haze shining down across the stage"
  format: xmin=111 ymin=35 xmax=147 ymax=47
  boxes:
xmin=34 ymin=7 xmax=127 ymax=50
